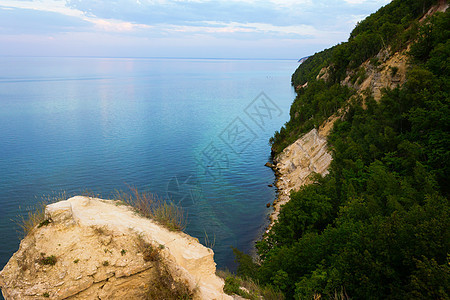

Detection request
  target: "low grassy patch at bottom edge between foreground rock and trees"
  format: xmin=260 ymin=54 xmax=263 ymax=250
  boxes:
xmin=216 ymin=270 xmax=284 ymax=300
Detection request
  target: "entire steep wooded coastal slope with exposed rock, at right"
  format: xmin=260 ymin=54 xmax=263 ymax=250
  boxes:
xmin=246 ymin=0 xmax=450 ymax=299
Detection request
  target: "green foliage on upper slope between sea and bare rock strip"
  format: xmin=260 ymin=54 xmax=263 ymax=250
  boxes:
xmin=270 ymin=0 xmax=437 ymax=154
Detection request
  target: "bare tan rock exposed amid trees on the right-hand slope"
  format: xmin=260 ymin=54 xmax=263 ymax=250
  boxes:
xmin=269 ymin=42 xmax=409 ymax=229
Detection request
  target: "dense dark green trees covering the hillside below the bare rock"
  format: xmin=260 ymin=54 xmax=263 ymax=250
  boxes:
xmin=237 ymin=0 xmax=450 ymax=299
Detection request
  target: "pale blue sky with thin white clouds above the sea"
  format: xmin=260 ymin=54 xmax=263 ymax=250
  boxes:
xmin=0 ymin=0 xmax=390 ymax=59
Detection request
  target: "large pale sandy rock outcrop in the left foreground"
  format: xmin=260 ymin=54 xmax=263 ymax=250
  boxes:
xmin=0 ymin=197 xmax=232 ymax=299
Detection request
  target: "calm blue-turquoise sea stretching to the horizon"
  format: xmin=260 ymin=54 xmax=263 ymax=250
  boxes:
xmin=0 ymin=57 xmax=297 ymax=269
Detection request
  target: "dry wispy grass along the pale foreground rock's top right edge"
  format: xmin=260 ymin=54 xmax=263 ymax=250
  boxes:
xmin=114 ymin=187 xmax=186 ymax=231
